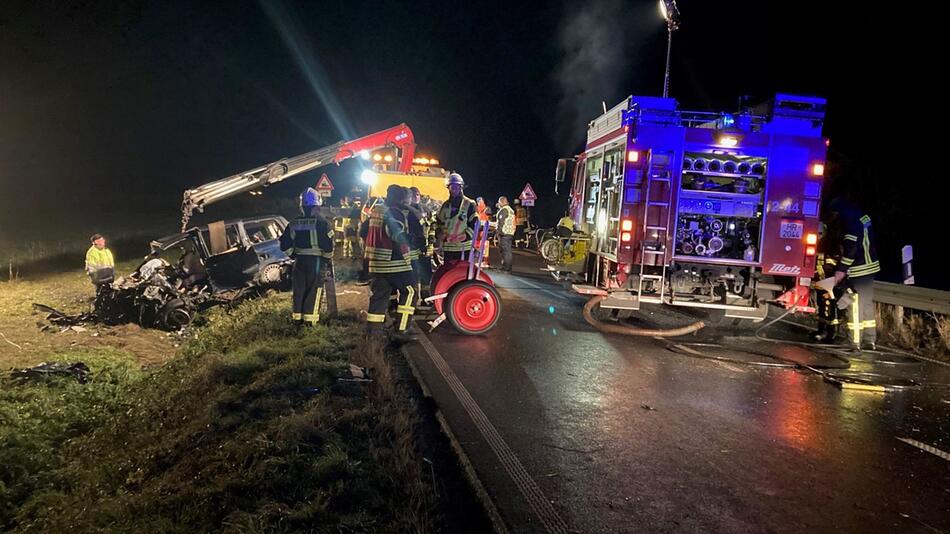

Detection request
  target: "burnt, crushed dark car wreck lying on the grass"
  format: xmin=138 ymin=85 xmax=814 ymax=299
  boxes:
xmin=34 ymin=215 xmax=293 ymax=330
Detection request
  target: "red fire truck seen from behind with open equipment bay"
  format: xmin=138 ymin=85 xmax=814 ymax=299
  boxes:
xmin=552 ymin=94 xmax=828 ymax=320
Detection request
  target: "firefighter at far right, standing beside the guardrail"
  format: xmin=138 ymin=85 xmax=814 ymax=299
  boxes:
xmin=829 ymin=197 xmax=881 ymax=350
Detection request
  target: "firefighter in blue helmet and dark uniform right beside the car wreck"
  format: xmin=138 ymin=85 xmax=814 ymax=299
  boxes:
xmin=280 ymin=191 xmax=333 ymax=326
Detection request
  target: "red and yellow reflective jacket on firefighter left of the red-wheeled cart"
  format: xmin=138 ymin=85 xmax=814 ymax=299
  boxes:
xmin=363 ymin=204 xmax=412 ymax=273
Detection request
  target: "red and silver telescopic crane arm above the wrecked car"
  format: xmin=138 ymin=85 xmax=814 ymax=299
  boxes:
xmin=181 ymin=123 xmax=416 ymax=232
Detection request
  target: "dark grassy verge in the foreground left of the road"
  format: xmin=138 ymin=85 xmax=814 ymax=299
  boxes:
xmin=0 ymin=295 xmax=432 ymax=532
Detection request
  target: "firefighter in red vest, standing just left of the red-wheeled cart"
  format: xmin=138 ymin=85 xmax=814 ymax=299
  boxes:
xmin=365 ymin=184 xmax=418 ymax=341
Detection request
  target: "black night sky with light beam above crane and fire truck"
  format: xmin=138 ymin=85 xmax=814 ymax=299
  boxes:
xmin=0 ymin=0 xmax=947 ymax=287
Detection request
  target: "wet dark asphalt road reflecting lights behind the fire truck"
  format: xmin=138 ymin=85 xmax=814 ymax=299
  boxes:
xmin=406 ymin=252 xmax=950 ymax=533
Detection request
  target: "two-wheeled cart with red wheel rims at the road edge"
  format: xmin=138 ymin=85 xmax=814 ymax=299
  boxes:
xmin=425 ymin=221 xmax=501 ymax=335
